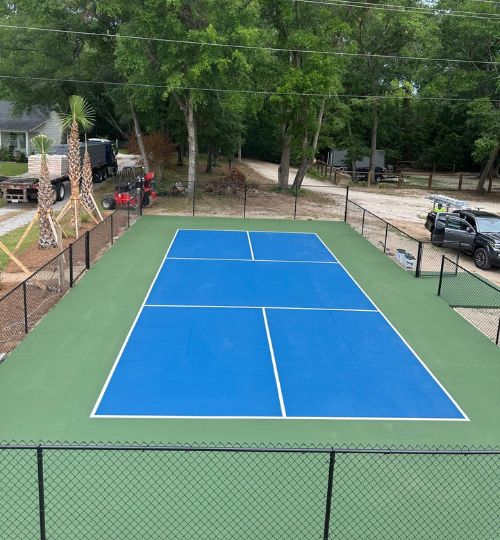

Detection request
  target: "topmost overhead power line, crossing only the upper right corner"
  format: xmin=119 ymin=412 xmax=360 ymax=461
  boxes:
xmin=293 ymin=0 xmax=500 ymax=21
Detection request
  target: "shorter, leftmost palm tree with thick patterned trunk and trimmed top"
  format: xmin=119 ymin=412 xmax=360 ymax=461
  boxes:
xmin=31 ymin=135 xmax=58 ymax=249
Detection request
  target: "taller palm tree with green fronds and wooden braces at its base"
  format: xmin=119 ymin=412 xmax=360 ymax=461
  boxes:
xmin=57 ymin=96 xmax=94 ymax=238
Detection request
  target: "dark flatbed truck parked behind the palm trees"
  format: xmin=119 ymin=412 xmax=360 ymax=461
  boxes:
xmin=0 ymin=139 xmax=118 ymax=203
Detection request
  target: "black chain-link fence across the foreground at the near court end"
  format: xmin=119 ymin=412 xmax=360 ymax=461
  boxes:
xmin=0 ymin=444 xmax=500 ymax=540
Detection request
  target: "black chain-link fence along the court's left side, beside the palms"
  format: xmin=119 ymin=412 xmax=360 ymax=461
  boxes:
xmin=0 ymin=207 xmax=140 ymax=353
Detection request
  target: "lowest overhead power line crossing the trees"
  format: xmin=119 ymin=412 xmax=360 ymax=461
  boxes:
xmin=0 ymin=75 xmax=499 ymax=103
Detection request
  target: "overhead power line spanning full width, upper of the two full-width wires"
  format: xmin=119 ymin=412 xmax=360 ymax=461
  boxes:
xmin=0 ymin=24 xmax=500 ymax=65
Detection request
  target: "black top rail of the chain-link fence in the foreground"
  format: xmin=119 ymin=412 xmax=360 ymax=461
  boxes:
xmin=0 ymin=443 xmax=500 ymax=456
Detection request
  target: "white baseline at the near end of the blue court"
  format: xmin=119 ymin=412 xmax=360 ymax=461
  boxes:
xmin=94 ymin=414 xmax=468 ymax=422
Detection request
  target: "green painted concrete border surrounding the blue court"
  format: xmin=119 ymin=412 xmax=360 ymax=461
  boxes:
xmin=0 ymin=216 xmax=500 ymax=447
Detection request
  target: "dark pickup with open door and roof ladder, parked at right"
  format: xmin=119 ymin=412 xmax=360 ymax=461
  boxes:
xmin=425 ymin=210 xmax=500 ymax=270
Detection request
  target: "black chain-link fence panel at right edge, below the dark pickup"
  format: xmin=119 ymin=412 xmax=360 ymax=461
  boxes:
xmin=438 ymin=256 xmax=500 ymax=345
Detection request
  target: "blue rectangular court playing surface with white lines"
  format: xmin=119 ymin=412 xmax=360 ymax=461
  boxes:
xmin=91 ymin=230 xmax=467 ymax=420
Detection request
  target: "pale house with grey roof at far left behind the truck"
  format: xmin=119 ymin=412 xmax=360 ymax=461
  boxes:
xmin=0 ymin=100 xmax=63 ymax=156
